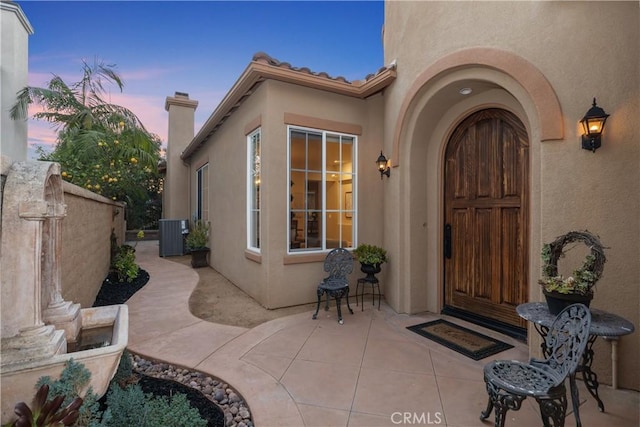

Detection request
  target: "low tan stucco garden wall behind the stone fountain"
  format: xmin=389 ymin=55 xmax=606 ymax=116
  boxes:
xmin=60 ymin=182 xmax=125 ymax=308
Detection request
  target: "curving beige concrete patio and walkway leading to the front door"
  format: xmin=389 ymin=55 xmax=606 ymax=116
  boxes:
xmin=127 ymin=241 xmax=640 ymax=427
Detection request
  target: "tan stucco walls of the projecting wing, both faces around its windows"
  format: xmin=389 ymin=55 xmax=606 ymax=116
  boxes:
xmin=185 ymin=80 xmax=386 ymax=308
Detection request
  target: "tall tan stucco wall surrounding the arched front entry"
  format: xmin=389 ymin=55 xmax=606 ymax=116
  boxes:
xmin=384 ymin=1 xmax=640 ymax=389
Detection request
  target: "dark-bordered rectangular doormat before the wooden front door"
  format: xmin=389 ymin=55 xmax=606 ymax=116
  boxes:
xmin=407 ymin=319 xmax=513 ymax=360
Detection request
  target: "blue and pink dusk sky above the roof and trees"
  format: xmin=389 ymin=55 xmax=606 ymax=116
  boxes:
xmin=17 ymin=0 xmax=384 ymax=155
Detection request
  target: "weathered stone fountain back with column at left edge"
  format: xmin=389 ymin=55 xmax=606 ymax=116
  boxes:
xmin=0 ymin=162 xmax=67 ymax=366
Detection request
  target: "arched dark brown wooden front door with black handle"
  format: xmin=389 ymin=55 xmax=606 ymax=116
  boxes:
xmin=444 ymin=108 xmax=529 ymax=328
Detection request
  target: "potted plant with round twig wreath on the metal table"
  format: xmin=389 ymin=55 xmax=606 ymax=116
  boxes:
xmin=538 ymin=231 xmax=606 ymax=314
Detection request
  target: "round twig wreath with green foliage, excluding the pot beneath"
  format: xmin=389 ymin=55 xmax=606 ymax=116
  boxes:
xmin=540 ymin=231 xmax=607 ymax=295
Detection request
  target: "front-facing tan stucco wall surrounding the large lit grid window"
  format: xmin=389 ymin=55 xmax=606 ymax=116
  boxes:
xmin=264 ymin=82 xmax=384 ymax=307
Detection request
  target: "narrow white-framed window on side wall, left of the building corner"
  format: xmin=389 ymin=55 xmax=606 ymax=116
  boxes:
xmin=247 ymin=129 xmax=262 ymax=252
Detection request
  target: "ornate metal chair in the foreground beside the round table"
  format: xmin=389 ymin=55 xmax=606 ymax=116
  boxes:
xmin=480 ymin=304 xmax=591 ymax=427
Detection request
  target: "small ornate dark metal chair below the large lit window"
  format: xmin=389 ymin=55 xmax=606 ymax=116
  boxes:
xmin=313 ymin=248 xmax=353 ymax=325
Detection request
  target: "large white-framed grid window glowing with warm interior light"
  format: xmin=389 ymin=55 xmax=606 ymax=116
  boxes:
xmin=287 ymin=126 xmax=357 ymax=253
